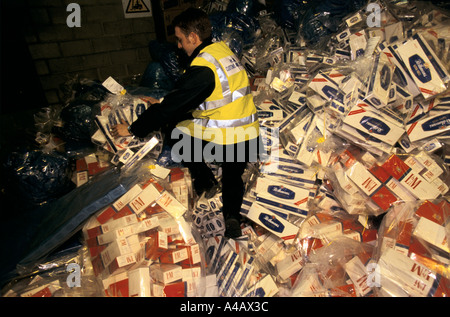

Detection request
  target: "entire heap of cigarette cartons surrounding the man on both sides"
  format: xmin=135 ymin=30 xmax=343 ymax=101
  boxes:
xmin=3 ymin=1 xmax=450 ymax=297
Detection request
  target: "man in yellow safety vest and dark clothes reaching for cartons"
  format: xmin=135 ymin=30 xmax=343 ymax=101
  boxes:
xmin=112 ymin=8 xmax=260 ymax=238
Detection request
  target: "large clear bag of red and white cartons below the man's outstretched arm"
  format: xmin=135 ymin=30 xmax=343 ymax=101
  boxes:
xmin=83 ymin=168 xmax=206 ymax=297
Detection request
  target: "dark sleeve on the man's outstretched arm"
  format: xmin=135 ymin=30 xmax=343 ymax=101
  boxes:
xmin=130 ymin=66 xmax=215 ymax=138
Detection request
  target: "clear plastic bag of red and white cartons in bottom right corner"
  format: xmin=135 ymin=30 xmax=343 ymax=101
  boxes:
xmin=376 ymin=199 xmax=450 ymax=297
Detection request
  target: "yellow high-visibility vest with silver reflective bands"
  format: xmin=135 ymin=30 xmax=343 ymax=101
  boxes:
xmin=177 ymin=42 xmax=259 ymax=144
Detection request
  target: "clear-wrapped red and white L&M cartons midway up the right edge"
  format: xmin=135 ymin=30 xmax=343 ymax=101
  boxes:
xmin=327 ymin=147 xmax=448 ymax=215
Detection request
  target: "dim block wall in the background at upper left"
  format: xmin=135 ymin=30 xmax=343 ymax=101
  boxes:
xmin=20 ymin=0 xmax=156 ymax=104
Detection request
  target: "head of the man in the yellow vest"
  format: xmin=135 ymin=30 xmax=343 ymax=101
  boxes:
xmin=173 ymin=8 xmax=211 ymax=56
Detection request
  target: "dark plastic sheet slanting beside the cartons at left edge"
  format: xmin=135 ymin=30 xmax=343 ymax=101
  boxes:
xmin=0 ymin=170 xmax=128 ymax=290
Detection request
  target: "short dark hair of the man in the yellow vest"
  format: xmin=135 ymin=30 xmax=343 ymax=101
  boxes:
xmin=172 ymin=8 xmax=211 ymax=41
